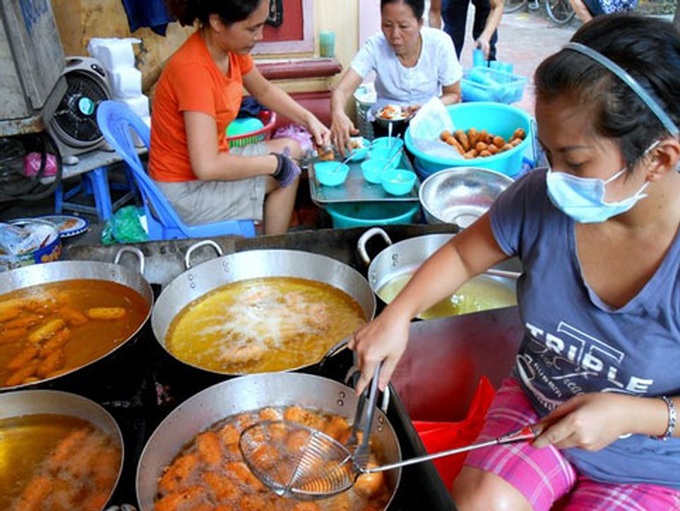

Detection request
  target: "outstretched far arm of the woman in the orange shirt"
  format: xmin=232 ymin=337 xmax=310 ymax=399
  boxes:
xmin=243 ymin=67 xmax=330 ymax=147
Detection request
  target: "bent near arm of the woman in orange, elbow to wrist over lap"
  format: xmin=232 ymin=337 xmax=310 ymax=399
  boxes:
xmin=184 ymin=111 xmax=278 ymax=181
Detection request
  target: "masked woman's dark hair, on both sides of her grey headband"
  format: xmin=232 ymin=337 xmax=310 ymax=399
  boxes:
xmin=534 ymin=13 xmax=680 ymax=169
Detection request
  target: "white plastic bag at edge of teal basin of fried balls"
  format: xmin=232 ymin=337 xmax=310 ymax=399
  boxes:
xmin=409 ymin=98 xmax=463 ymax=159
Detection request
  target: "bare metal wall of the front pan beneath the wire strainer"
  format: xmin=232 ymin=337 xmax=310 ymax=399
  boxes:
xmin=136 ymin=373 xmax=401 ymax=511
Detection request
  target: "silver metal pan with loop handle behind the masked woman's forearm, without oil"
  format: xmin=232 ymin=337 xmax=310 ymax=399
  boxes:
xmin=357 ymin=227 xmax=519 ymax=318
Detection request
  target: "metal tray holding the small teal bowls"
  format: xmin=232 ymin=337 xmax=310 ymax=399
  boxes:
xmin=308 ymin=152 xmax=420 ymax=206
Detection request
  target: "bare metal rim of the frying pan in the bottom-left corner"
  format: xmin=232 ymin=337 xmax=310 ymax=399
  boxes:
xmin=0 ymin=390 xmax=124 ymax=509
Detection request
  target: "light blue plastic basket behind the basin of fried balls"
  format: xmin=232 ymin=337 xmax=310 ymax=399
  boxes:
xmin=461 ymin=66 xmax=527 ymax=104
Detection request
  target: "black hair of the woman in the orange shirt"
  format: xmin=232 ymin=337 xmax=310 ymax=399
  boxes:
xmin=165 ymin=0 xmax=265 ymax=26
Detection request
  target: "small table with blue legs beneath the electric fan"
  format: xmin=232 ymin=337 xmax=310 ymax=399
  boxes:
xmin=40 ymin=147 xmax=147 ymax=221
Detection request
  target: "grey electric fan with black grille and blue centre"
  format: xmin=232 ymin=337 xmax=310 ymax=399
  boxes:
xmin=47 ymin=57 xmax=111 ymax=165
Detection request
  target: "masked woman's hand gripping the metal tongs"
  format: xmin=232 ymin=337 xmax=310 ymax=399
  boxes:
xmin=349 ymin=306 xmax=410 ymax=394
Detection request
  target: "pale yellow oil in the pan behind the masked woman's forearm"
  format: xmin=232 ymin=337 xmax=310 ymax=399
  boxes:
xmin=377 ymin=273 xmax=517 ymax=319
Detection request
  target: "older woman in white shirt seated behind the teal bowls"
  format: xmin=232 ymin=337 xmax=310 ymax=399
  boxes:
xmin=331 ymin=0 xmax=463 ymax=153
